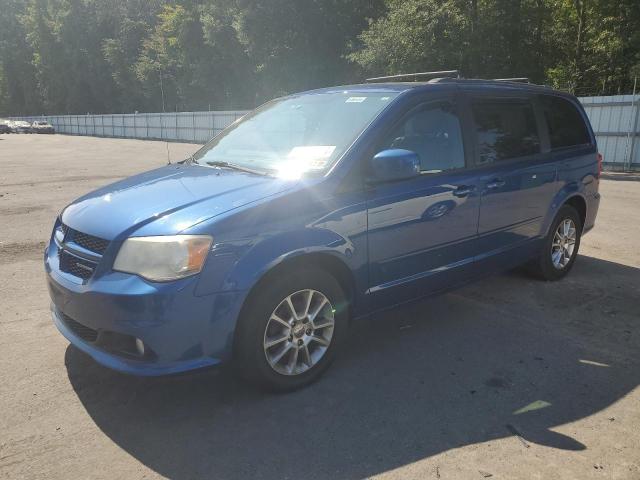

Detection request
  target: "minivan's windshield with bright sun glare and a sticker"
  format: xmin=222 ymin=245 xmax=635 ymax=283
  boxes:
xmin=194 ymin=92 xmax=398 ymax=177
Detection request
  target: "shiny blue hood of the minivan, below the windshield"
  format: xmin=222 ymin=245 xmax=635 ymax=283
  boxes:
xmin=62 ymin=165 xmax=296 ymax=240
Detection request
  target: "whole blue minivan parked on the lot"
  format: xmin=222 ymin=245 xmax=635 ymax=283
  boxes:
xmin=44 ymin=78 xmax=602 ymax=390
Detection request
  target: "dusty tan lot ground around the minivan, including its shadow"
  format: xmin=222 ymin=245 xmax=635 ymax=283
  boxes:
xmin=0 ymin=135 xmax=640 ymax=480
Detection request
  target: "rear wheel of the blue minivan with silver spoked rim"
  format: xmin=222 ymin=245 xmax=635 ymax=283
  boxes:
xmin=530 ymin=205 xmax=582 ymax=281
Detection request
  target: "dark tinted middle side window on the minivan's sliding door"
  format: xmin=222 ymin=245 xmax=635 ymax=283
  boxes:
xmin=473 ymin=100 xmax=540 ymax=164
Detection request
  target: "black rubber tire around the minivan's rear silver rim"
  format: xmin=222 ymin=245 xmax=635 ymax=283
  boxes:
xmin=529 ymin=205 xmax=582 ymax=281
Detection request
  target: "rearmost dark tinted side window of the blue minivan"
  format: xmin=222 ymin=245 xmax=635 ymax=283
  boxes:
xmin=540 ymin=95 xmax=591 ymax=149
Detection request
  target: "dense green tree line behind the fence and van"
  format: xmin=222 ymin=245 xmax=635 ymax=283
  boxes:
xmin=0 ymin=0 xmax=640 ymax=116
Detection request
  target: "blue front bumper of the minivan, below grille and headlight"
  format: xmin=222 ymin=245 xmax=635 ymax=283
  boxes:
xmin=45 ymin=245 xmax=243 ymax=376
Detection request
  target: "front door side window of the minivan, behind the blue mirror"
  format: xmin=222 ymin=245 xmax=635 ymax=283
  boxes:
xmin=382 ymin=103 xmax=465 ymax=173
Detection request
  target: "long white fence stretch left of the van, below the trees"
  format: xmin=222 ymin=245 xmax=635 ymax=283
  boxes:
xmin=14 ymin=110 xmax=247 ymax=143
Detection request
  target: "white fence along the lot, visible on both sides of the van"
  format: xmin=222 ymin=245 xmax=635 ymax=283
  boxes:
xmin=8 ymin=95 xmax=640 ymax=169
